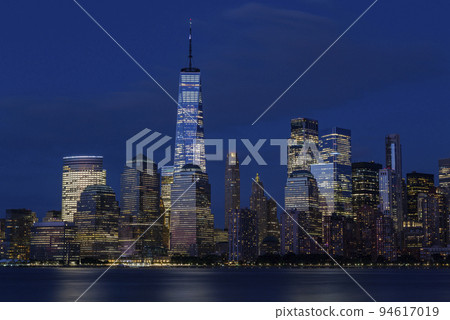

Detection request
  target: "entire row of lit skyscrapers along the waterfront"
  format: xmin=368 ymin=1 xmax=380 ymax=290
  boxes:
xmin=0 ymin=26 xmax=450 ymax=264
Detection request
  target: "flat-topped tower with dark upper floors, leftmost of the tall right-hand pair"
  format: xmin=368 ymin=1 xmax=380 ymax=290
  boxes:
xmin=288 ymin=118 xmax=320 ymax=176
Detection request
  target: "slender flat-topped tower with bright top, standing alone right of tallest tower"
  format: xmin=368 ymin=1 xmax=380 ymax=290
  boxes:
xmin=225 ymin=152 xmax=241 ymax=229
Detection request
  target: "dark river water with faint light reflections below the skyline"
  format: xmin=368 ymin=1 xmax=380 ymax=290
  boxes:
xmin=0 ymin=268 xmax=450 ymax=302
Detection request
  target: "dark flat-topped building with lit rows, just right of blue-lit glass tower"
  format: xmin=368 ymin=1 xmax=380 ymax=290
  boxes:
xmin=352 ymin=162 xmax=382 ymax=214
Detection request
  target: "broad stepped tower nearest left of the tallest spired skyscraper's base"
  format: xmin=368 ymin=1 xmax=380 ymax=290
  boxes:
xmin=119 ymin=156 xmax=165 ymax=261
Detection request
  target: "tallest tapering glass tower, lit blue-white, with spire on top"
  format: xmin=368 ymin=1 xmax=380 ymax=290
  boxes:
xmin=174 ymin=23 xmax=206 ymax=173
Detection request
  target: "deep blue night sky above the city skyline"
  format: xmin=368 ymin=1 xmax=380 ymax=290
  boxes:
xmin=0 ymin=0 xmax=450 ymax=227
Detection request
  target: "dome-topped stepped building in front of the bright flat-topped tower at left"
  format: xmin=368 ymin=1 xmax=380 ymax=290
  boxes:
xmin=74 ymin=185 xmax=120 ymax=261
